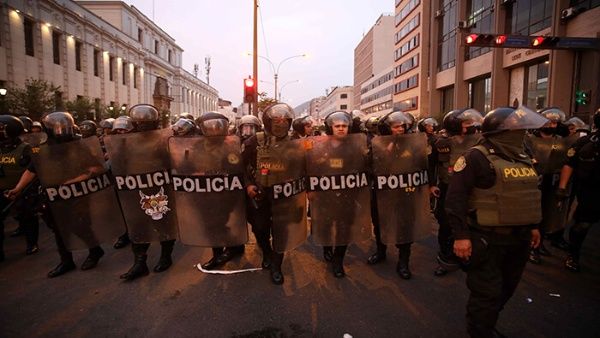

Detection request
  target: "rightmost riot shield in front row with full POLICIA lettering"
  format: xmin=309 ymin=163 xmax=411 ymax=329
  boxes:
xmin=372 ymin=133 xmax=431 ymax=245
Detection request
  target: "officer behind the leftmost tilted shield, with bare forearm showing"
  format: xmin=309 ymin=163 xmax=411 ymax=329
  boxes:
xmin=7 ymin=112 xmax=104 ymax=278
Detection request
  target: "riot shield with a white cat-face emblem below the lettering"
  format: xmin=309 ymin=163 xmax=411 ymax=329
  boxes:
xmin=104 ymin=129 xmax=177 ymax=243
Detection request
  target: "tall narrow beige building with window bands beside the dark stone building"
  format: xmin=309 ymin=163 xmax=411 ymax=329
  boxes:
xmin=393 ymin=0 xmax=431 ymax=116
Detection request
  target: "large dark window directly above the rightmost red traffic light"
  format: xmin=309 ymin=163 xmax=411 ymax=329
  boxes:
xmin=506 ymin=0 xmax=554 ymax=35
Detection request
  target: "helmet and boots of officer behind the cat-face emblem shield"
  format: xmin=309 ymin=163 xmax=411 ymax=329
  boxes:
xmin=119 ymin=104 xmax=175 ymax=280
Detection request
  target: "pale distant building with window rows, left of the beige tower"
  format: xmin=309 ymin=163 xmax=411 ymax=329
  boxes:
xmin=360 ymin=64 xmax=394 ymax=116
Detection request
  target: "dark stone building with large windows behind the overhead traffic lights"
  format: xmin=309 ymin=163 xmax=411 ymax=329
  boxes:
xmin=426 ymin=0 xmax=600 ymax=121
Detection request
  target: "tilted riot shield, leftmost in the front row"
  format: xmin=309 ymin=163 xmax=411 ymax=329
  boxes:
xmin=33 ymin=137 xmax=125 ymax=250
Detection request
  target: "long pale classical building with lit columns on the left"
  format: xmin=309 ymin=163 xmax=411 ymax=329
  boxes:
xmin=0 ymin=0 xmax=218 ymax=118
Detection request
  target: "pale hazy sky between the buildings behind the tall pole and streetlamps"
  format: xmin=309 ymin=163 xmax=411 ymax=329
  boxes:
xmin=124 ymin=0 xmax=394 ymax=106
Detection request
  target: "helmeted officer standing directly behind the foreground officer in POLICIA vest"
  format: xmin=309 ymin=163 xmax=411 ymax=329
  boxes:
xmin=429 ymin=109 xmax=483 ymax=276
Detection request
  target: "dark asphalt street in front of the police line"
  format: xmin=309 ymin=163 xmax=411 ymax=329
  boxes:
xmin=0 ymin=219 xmax=600 ymax=337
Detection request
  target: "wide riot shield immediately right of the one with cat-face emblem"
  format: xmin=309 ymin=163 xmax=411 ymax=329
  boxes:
xmin=169 ymin=136 xmax=248 ymax=247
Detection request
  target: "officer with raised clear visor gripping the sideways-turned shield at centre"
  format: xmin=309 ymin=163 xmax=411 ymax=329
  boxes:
xmin=242 ymin=103 xmax=294 ymax=285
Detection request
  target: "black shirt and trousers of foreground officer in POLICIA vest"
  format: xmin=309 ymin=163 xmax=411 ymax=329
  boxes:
xmin=445 ymin=142 xmax=532 ymax=337
